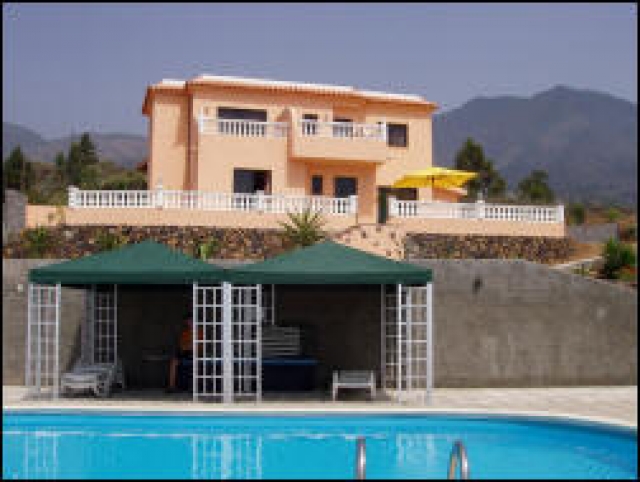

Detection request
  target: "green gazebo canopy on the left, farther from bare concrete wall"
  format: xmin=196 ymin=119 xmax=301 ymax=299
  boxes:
xmin=29 ymin=241 xmax=226 ymax=286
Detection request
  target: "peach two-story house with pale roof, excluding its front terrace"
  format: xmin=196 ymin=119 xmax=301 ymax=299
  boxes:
xmin=142 ymin=75 xmax=458 ymax=222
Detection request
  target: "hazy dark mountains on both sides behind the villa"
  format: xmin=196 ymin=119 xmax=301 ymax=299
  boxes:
xmin=2 ymin=87 xmax=638 ymax=205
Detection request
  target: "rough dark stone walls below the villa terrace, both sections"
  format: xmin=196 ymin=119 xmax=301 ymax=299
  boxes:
xmin=3 ymin=225 xmax=573 ymax=263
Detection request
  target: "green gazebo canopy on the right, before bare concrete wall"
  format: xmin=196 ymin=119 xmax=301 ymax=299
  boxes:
xmin=228 ymin=241 xmax=432 ymax=284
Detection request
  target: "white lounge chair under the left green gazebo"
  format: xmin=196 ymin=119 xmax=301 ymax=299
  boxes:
xmin=60 ymin=360 xmax=125 ymax=398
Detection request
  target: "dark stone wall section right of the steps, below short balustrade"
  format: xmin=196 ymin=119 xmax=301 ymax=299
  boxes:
xmin=404 ymin=233 xmax=572 ymax=263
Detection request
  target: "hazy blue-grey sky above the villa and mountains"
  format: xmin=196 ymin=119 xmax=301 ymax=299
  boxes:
xmin=2 ymin=3 xmax=638 ymax=137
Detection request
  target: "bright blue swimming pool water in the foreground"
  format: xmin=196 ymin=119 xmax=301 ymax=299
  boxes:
xmin=2 ymin=412 xmax=638 ymax=479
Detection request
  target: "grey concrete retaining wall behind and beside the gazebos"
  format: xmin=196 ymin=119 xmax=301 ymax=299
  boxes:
xmin=3 ymin=259 xmax=637 ymax=387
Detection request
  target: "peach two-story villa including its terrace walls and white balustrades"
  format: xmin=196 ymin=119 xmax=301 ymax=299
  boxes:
xmin=27 ymin=75 xmax=565 ymax=244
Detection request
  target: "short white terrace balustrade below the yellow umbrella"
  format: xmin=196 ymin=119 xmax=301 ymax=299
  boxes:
xmin=389 ymin=199 xmax=564 ymax=223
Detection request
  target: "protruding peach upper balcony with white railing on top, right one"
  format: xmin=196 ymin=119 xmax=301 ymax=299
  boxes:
xmin=292 ymin=120 xmax=389 ymax=164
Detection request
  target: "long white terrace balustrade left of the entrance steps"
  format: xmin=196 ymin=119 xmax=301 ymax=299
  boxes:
xmin=69 ymin=187 xmax=358 ymax=216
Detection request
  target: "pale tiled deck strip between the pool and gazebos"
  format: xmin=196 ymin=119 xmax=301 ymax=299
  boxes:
xmin=2 ymin=386 xmax=638 ymax=427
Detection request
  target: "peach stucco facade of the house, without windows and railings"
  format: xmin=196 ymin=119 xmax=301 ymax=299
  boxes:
xmin=149 ymin=85 xmax=433 ymax=221
